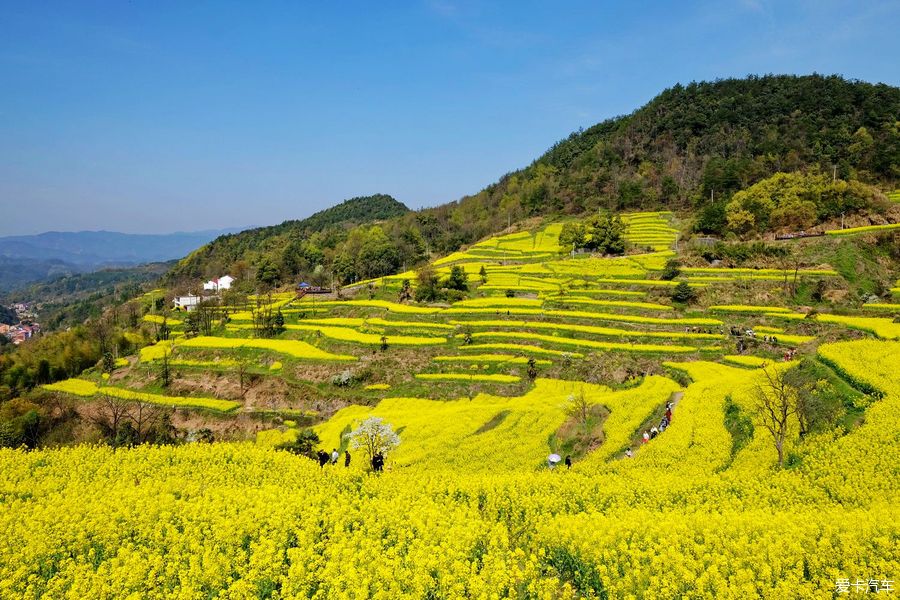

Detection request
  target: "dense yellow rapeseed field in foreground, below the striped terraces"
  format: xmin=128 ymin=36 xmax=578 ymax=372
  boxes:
xmin=7 ymin=340 xmax=900 ymax=598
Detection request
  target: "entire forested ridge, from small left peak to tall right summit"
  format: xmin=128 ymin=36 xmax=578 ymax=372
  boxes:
xmin=165 ymin=75 xmax=900 ymax=284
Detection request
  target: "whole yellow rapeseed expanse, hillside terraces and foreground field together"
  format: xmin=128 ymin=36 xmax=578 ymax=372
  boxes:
xmin=22 ymin=213 xmax=900 ymax=598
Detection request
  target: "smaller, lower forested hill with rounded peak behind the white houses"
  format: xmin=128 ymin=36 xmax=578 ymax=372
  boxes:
xmin=167 ymin=194 xmax=410 ymax=282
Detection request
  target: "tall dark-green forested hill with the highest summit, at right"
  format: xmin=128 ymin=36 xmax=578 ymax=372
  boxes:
xmin=528 ymin=75 xmax=900 ymax=213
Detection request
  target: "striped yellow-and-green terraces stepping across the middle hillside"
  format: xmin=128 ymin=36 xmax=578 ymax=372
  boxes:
xmin=44 ymin=213 xmax=900 ymax=422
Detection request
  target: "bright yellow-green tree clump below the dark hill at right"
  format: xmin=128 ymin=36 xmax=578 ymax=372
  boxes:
xmin=724 ymin=172 xmax=889 ymax=234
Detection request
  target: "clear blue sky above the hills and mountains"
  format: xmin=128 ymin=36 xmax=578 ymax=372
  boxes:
xmin=0 ymin=0 xmax=900 ymax=235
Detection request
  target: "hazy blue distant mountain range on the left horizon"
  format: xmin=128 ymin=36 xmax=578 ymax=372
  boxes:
xmin=0 ymin=228 xmax=244 ymax=291
